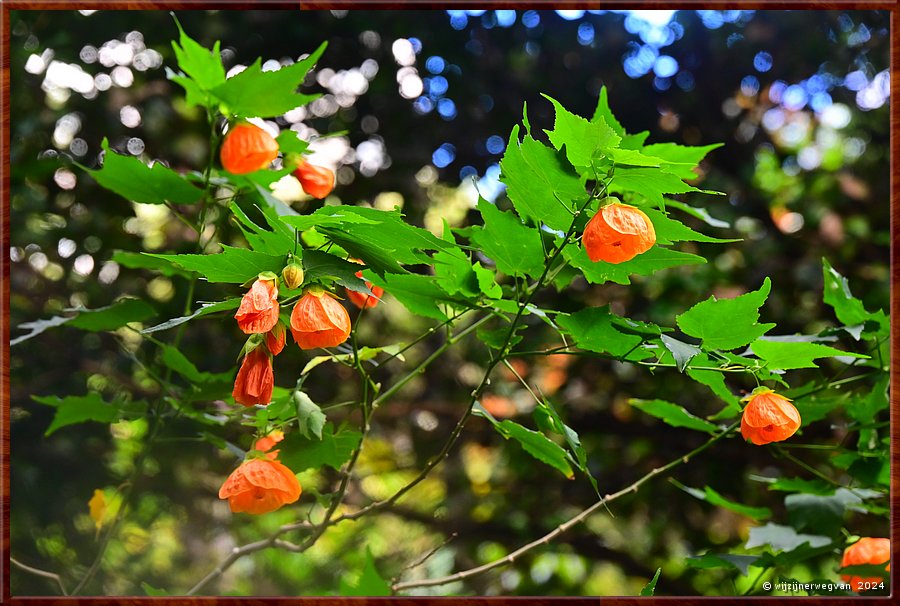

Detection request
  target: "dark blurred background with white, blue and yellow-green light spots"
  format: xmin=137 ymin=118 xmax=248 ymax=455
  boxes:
xmin=10 ymin=10 xmax=890 ymax=595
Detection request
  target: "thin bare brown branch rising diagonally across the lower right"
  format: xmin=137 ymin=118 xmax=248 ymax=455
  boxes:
xmin=391 ymin=421 xmax=740 ymax=592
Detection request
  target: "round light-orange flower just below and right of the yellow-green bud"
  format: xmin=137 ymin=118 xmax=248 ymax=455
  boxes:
xmin=291 ymin=289 xmax=350 ymax=349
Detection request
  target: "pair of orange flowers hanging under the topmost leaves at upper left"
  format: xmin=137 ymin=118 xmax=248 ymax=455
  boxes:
xmin=220 ymin=122 xmax=334 ymax=200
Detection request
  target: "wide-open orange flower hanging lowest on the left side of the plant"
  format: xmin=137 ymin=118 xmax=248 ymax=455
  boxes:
xmin=219 ymin=459 xmax=302 ymax=514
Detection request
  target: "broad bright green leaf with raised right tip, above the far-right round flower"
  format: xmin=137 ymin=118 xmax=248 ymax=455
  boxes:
xmin=675 ymin=278 xmax=775 ymax=349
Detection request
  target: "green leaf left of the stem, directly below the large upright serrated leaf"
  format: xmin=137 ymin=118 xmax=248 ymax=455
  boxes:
xmin=471 ymin=198 xmax=544 ymax=277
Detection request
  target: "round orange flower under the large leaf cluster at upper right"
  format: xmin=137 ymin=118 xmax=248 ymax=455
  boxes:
xmin=582 ymin=202 xmax=656 ymax=263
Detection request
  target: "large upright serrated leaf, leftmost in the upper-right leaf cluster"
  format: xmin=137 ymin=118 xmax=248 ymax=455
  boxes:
xmin=500 ymin=125 xmax=587 ymax=231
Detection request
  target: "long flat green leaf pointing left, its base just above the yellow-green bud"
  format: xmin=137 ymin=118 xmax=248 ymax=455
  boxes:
xmin=143 ymin=246 xmax=287 ymax=284
